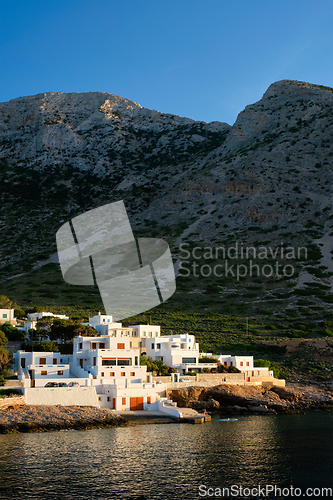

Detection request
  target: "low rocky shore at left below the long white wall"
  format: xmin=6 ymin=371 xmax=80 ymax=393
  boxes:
xmin=0 ymin=404 xmax=128 ymax=434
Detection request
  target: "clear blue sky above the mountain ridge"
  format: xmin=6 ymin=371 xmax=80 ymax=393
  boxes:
xmin=0 ymin=0 xmax=333 ymax=124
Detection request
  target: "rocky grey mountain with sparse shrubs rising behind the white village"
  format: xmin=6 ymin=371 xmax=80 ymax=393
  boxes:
xmin=0 ymin=80 xmax=333 ymax=331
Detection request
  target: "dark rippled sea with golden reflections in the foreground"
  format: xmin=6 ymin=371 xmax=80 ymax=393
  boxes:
xmin=0 ymin=411 xmax=333 ymax=500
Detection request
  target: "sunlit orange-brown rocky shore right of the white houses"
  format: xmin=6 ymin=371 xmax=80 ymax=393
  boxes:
xmin=168 ymin=384 xmax=333 ymax=414
